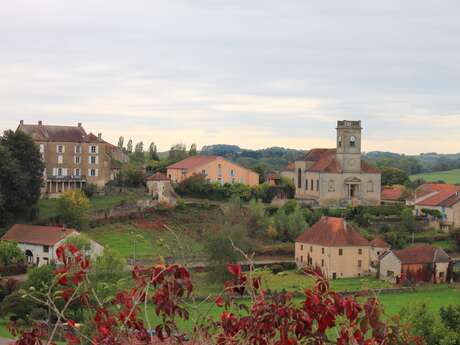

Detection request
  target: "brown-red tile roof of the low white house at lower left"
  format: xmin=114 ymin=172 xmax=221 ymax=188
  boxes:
xmin=2 ymin=224 xmax=77 ymax=246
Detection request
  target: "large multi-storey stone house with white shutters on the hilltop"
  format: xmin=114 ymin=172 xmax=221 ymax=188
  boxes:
xmin=18 ymin=120 xmax=128 ymax=196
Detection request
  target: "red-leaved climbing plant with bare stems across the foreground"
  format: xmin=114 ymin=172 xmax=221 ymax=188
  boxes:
xmin=9 ymin=244 xmax=424 ymax=345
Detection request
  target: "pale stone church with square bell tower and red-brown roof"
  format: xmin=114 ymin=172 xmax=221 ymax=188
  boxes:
xmin=294 ymin=121 xmax=381 ymax=207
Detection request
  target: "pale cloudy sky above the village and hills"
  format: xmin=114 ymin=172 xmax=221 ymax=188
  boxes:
xmin=0 ymin=0 xmax=460 ymax=154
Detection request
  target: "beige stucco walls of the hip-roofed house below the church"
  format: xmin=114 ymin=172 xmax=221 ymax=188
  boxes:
xmin=295 ymin=242 xmax=371 ymax=278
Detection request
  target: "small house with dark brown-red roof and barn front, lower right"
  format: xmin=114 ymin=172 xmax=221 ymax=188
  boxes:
xmin=379 ymin=244 xmax=451 ymax=283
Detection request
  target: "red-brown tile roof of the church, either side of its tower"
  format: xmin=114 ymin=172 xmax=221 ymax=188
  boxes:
xmin=304 ymin=149 xmax=380 ymax=174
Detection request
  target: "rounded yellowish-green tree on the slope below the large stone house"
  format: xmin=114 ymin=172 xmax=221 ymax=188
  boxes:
xmin=58 ymin=189 xmax=91 ymax=229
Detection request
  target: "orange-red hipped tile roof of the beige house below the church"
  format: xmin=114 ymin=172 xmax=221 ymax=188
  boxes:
xmin=296 ymin=217 xmax=369 ymax=247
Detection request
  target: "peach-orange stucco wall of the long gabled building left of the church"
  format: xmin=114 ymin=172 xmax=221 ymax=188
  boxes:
xmin=167 ymin=157 xmax=259 ymax=186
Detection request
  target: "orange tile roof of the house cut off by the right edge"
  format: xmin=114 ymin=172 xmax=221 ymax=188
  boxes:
xmin=415 ymin=183 xmax=460 ymax=207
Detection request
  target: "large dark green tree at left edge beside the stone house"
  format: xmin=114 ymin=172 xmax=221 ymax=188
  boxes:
xmin=0 ymin=130 xmax=44 ymax=225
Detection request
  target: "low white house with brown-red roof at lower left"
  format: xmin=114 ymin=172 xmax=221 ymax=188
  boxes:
xmin=1 ymin=224 xmax=104 ymax=266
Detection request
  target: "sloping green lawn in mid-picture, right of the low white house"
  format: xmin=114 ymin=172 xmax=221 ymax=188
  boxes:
xmin=84 ymin=222 xmax=203 ymax=260
